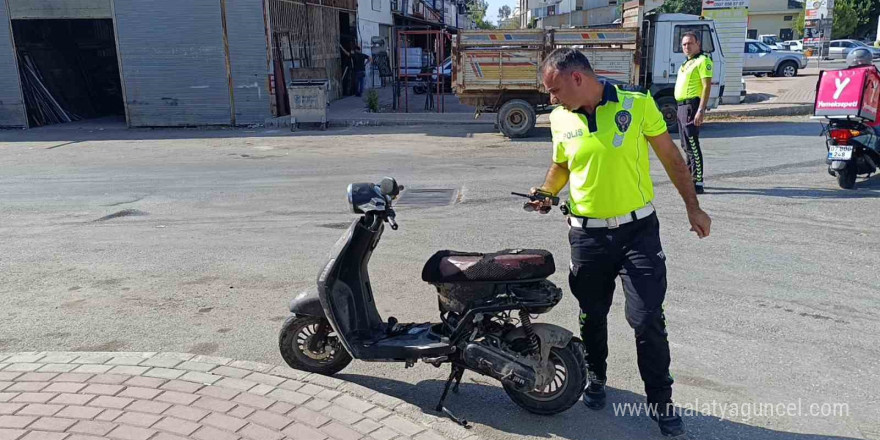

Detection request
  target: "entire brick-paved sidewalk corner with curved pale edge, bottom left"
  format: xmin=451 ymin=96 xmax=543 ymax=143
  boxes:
xmin=0 ymin=352 xmax=478 ymax=440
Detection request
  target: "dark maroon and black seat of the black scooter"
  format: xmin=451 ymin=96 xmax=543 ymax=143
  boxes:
xmin=422 ymin=249 xmax=556 ymax=284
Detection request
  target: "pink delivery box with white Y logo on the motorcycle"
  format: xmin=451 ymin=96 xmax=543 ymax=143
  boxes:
xmin=813 ymin=66 xmax=880 ymax=122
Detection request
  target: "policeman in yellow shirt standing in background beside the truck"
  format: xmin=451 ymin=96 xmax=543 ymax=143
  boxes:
xmin=675 ymin=32 xmax=713 ymax=194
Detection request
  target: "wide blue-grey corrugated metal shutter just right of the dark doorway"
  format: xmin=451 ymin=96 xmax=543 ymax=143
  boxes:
xmin=114 ymin=0 xmax=234 ymax=127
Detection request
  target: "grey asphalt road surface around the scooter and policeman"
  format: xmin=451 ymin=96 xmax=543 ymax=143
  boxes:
xmin=0 ymin=118 xmax=880 ymax=440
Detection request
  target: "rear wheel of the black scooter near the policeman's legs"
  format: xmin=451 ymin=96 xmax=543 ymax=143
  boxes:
xmin=504 ymin=339 xmax=587 ymax=415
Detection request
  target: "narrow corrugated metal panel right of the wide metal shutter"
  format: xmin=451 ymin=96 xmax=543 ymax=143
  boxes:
xmin=226 ymin=0 xmax=271 ymax=124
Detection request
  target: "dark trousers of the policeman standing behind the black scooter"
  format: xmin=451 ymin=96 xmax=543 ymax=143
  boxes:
xmin=568 ymin=214 xmax=673 ymax=404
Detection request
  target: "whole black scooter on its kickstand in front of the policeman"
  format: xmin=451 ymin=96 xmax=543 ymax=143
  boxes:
xmin=279 ymin=178 xmax=586 ymax=426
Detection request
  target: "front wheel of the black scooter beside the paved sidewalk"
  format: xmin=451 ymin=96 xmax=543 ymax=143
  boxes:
xmin=278 ymin=315 xmax=351 ymax=376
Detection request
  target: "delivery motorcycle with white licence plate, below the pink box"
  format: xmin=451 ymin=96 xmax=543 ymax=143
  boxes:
xmin=823 ymin=118 xmax=880 ymax=189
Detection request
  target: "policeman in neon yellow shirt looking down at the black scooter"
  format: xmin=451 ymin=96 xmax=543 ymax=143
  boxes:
xmin=530 ymin=49 xmax=711 ymax=436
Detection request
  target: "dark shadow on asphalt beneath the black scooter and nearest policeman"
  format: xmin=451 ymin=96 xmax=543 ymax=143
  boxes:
xmin=338 ymin=372 xmax=849 ymax=440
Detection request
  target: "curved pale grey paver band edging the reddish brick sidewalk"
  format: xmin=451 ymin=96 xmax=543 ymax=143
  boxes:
xmin=0 ymin=352 xmax=480 ymax=440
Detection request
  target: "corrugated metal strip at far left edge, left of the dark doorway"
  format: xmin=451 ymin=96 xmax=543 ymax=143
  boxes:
xmin=0 ymin=0 xmax=27 ymax=127
